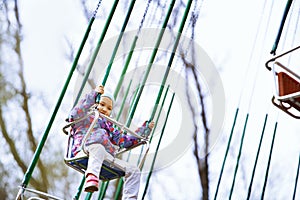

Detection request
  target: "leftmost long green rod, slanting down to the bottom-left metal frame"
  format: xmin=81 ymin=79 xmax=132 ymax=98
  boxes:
xmin=18 ymin=10 xmax=95 ymax=191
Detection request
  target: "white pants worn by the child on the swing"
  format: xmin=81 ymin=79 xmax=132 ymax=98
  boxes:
xmin=85 ymin=144 xmax=141 ymax=200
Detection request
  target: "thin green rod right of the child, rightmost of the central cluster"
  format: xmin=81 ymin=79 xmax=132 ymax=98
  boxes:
xmin=142 ymin=93 xmax=175 ymax=199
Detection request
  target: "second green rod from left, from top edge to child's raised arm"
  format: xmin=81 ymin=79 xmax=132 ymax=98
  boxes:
xmin=74 ymin=0 xmax=119 ymax=106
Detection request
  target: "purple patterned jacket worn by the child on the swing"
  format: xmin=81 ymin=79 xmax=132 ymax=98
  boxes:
xmin=69 ymin=90 xmax=150 ymax=156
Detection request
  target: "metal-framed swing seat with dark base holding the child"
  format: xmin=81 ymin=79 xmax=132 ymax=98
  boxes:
xmin=63 ymin=110 xmax=148 ymax=181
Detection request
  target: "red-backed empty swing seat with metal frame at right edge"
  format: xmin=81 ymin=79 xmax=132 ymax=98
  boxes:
xmin=272 ymin=62 xmax=300 ymax=119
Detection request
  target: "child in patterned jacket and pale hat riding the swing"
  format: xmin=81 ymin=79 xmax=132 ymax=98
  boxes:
xmin=69 ymin=86 xmax=154 ymax=199
